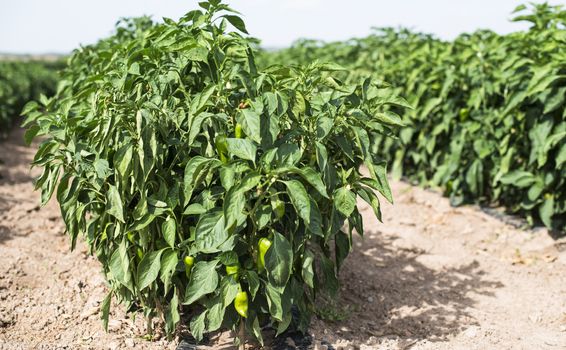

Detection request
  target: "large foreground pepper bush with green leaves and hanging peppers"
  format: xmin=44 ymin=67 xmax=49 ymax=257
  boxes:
xmin=25 ymin=0 xmax=408 ymax=341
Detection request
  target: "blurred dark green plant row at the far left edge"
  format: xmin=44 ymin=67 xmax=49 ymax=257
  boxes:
xmin=0 ymin=61 xmax=61 ymax=138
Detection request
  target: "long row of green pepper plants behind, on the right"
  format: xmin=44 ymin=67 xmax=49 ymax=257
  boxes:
xmin=261 ymin=4 xmax=566 ymax=232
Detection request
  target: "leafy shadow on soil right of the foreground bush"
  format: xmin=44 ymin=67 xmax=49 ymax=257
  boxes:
xmin=324 ymin=234 xmax=503 ymax=342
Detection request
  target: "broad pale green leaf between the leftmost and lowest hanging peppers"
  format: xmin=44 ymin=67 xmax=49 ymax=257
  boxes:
xmin=183 ymin=260 xmax=218 ymax=305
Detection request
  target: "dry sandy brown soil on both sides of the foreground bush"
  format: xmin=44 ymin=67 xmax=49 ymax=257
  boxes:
xmin=0 ymin=130 xmax=566 ymax=350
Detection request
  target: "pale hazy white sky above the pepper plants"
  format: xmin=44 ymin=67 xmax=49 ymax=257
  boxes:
xmin=0 ymin=0 xmax=566 ymax=53
